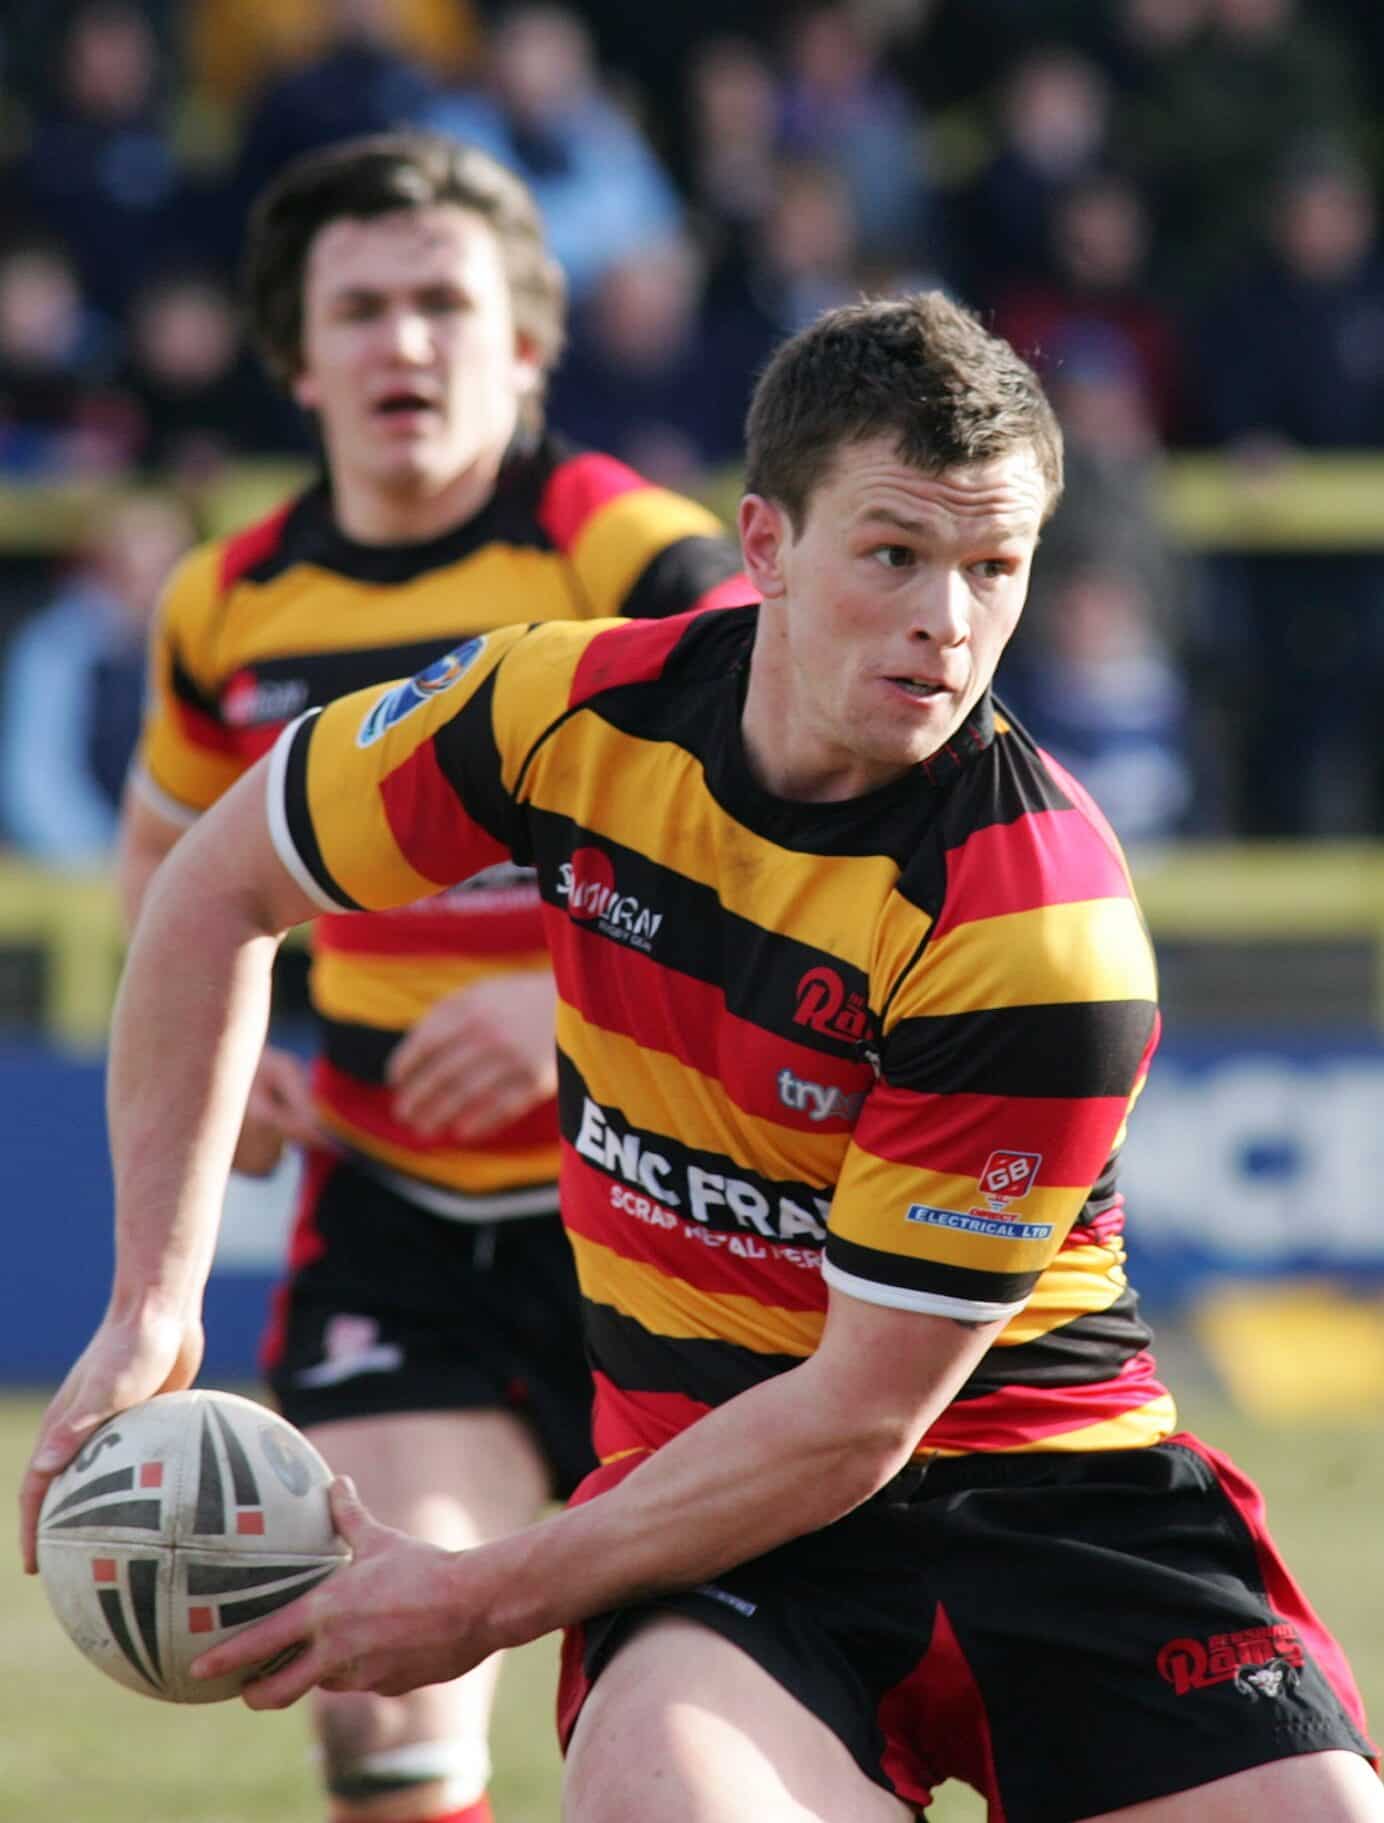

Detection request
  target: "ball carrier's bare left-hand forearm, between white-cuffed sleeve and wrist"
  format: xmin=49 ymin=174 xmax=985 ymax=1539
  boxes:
xmin=108 ymin=868 xmax=277 ymax=1318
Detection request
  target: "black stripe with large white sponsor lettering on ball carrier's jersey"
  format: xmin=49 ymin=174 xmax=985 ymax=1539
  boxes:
xmin=558 ymin=1052 xmax=830 ymax=1247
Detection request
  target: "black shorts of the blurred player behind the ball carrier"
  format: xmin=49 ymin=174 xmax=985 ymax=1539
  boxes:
xmin=261 ymin=1154 xmax=594 ymax=1495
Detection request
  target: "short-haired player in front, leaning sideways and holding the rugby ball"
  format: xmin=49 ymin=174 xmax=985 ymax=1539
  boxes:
xmin=26 ymin=294 xmax=1384 ymax=1823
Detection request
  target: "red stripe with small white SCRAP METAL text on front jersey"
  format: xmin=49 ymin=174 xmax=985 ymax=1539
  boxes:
xmin=562 ymin=1141 xmax=826 ymax=1311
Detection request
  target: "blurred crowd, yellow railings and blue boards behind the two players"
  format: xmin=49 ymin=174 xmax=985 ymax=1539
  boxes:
xmin=0 ymin=0 xmax=1384 ymax=1816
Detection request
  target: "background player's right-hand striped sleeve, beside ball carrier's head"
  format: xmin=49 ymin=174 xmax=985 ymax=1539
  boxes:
xmin=543 ymin=454 xmax=755 ymax=620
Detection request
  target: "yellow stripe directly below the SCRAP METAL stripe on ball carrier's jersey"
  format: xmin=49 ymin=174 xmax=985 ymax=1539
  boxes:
xmin=567 ymin=1229 xmax=824 ymax=1360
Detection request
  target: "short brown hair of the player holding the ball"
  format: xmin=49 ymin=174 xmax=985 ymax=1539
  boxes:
xmin=746 ymin=292 xmax=1063 ymax=530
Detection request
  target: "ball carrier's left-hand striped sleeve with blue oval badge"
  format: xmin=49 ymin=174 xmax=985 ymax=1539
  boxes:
xmin=268 ymin=622 xmax=583 ymax=912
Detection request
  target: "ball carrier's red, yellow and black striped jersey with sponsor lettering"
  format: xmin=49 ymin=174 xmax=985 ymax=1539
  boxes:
xmin=270 ymin=609 xmax=1174 ymax=1462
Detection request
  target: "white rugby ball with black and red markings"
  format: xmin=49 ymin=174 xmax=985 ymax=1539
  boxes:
xmin=38 ymin=1389 xmax=350 ymax=1703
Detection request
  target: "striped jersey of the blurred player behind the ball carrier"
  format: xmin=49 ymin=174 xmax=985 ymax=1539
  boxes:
xmin=137 ymin=438 xmax=749 ymax=1218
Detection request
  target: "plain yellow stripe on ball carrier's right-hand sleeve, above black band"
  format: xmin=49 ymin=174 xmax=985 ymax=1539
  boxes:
xmin=910 ymin=899 xmax=1156 ymax=1017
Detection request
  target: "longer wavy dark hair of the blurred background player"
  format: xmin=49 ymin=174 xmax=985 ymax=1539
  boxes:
xmin=244 ymin=131 xmax=567 ymax=414
